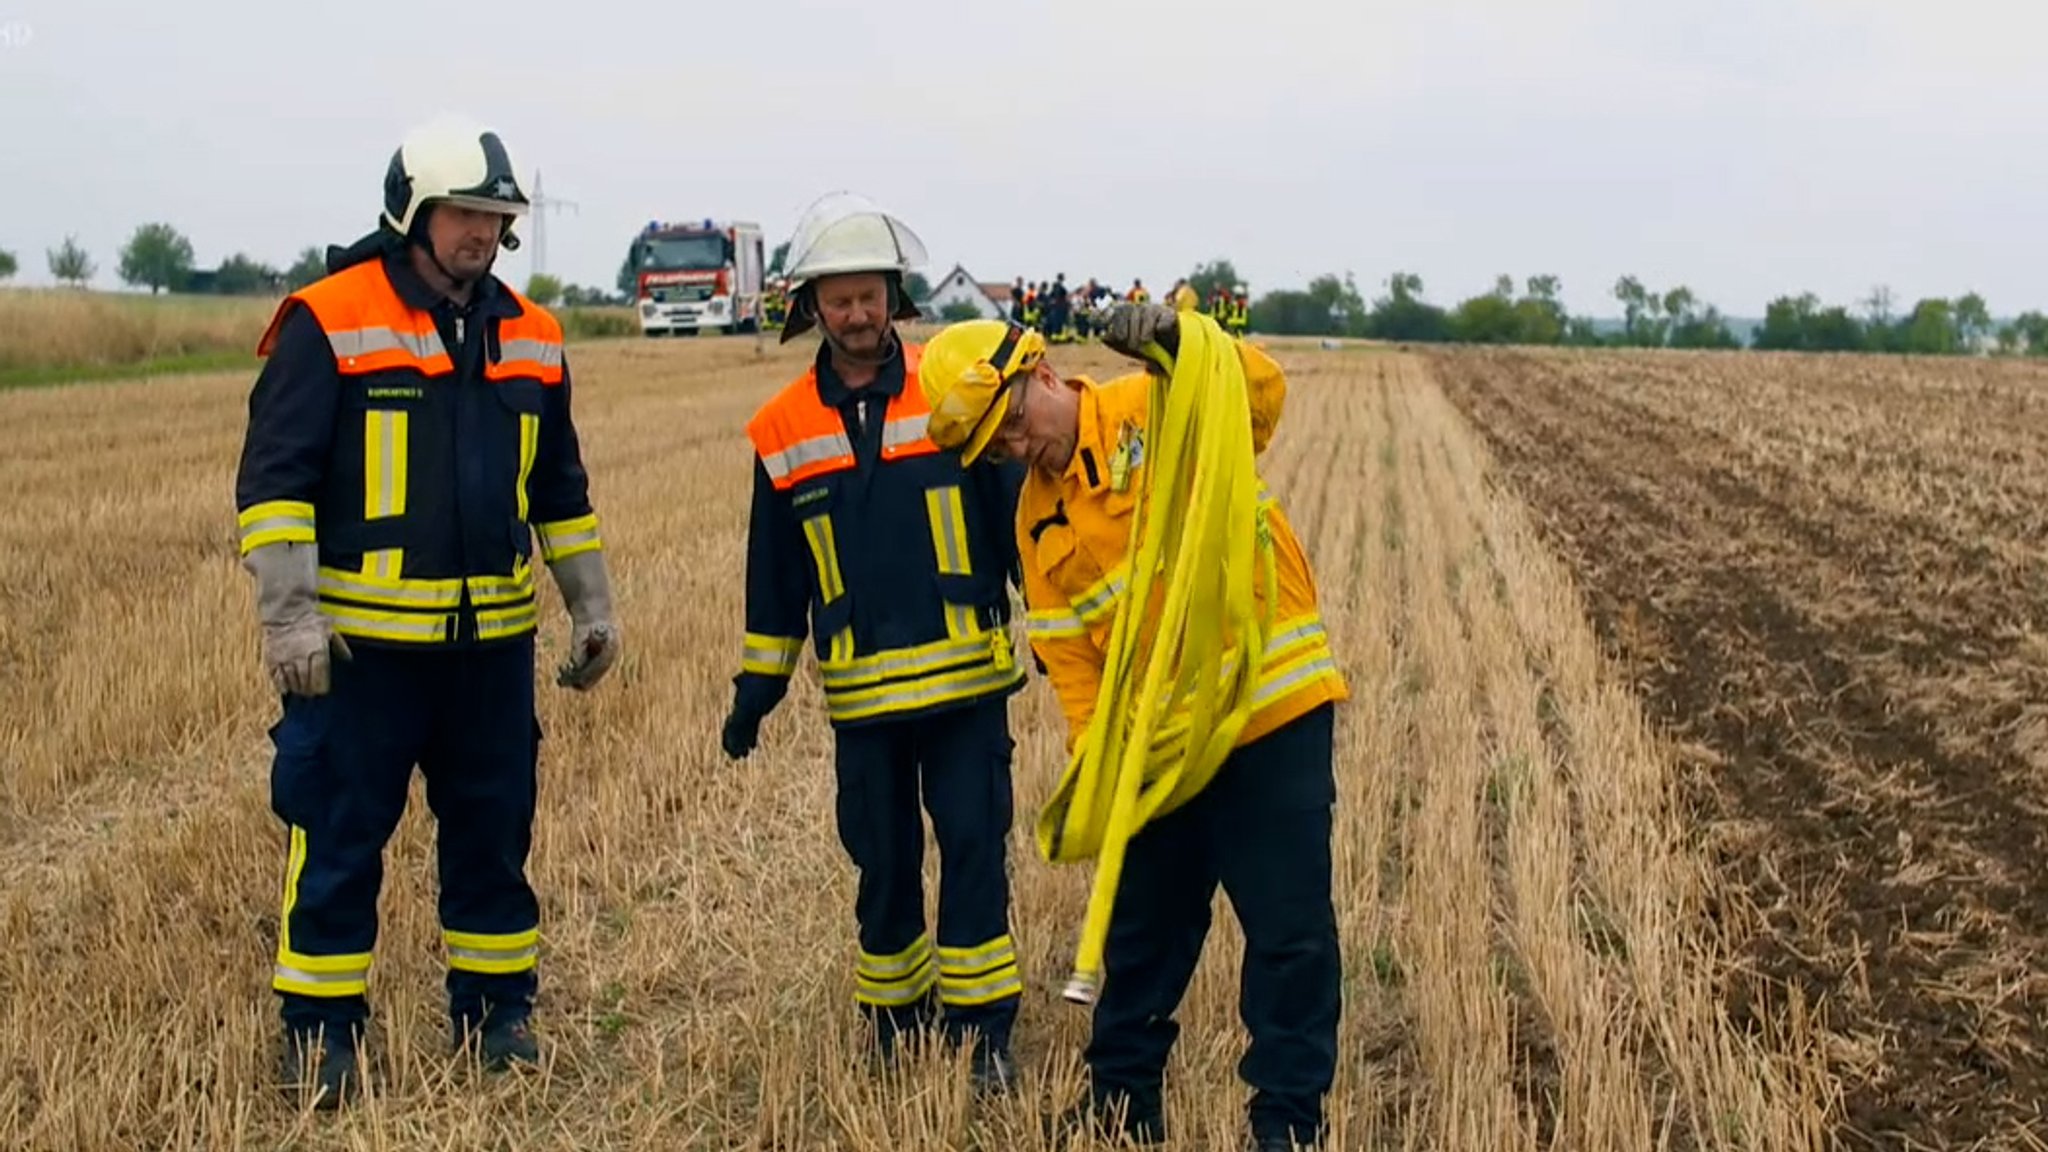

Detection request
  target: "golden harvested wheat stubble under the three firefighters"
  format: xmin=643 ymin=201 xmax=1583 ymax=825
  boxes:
xmin=0 ymin=340 xmax=1827 ymax=1152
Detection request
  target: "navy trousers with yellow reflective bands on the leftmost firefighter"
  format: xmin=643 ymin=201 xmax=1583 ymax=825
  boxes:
xmin=270 ymin=635 xmax=541 ymax=1029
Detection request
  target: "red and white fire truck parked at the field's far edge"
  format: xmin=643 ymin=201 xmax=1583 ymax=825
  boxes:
xmin=631 ymin=219 xmax=766 ymax=336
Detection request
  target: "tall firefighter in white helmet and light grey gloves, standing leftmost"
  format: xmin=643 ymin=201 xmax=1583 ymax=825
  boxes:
xmin=236 ymin=119 xmax=618 ymax=1107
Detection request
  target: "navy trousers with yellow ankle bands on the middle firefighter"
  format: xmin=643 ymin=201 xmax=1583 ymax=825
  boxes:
xmin=836 ymin=697 xmax=1024 ymax=1047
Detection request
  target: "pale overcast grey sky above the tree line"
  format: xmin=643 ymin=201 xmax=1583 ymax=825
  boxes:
xmin=0 ymin=0 xmax=2048 ymax=316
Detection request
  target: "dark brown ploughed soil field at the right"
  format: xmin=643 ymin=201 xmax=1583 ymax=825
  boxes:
xmin=1430 ymin=351 xmax=2048 ymax=1148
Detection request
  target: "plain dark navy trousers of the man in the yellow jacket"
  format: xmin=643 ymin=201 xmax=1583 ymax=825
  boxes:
xmin=1085 ymin=703 xmax=1341 ymax=1144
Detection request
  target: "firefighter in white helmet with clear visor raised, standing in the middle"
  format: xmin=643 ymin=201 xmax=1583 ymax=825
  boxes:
xmin=723 ymin=193 xmax=1024 ymax=1091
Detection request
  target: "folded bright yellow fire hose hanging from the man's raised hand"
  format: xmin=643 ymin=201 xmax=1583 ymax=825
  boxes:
xmin=1038 ymin=312 xmax=1278 ymax=1004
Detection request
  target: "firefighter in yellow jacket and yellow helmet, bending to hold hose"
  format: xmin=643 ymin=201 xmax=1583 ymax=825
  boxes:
xmin=922 ymin=303 xmax=1348 ymax=1150
